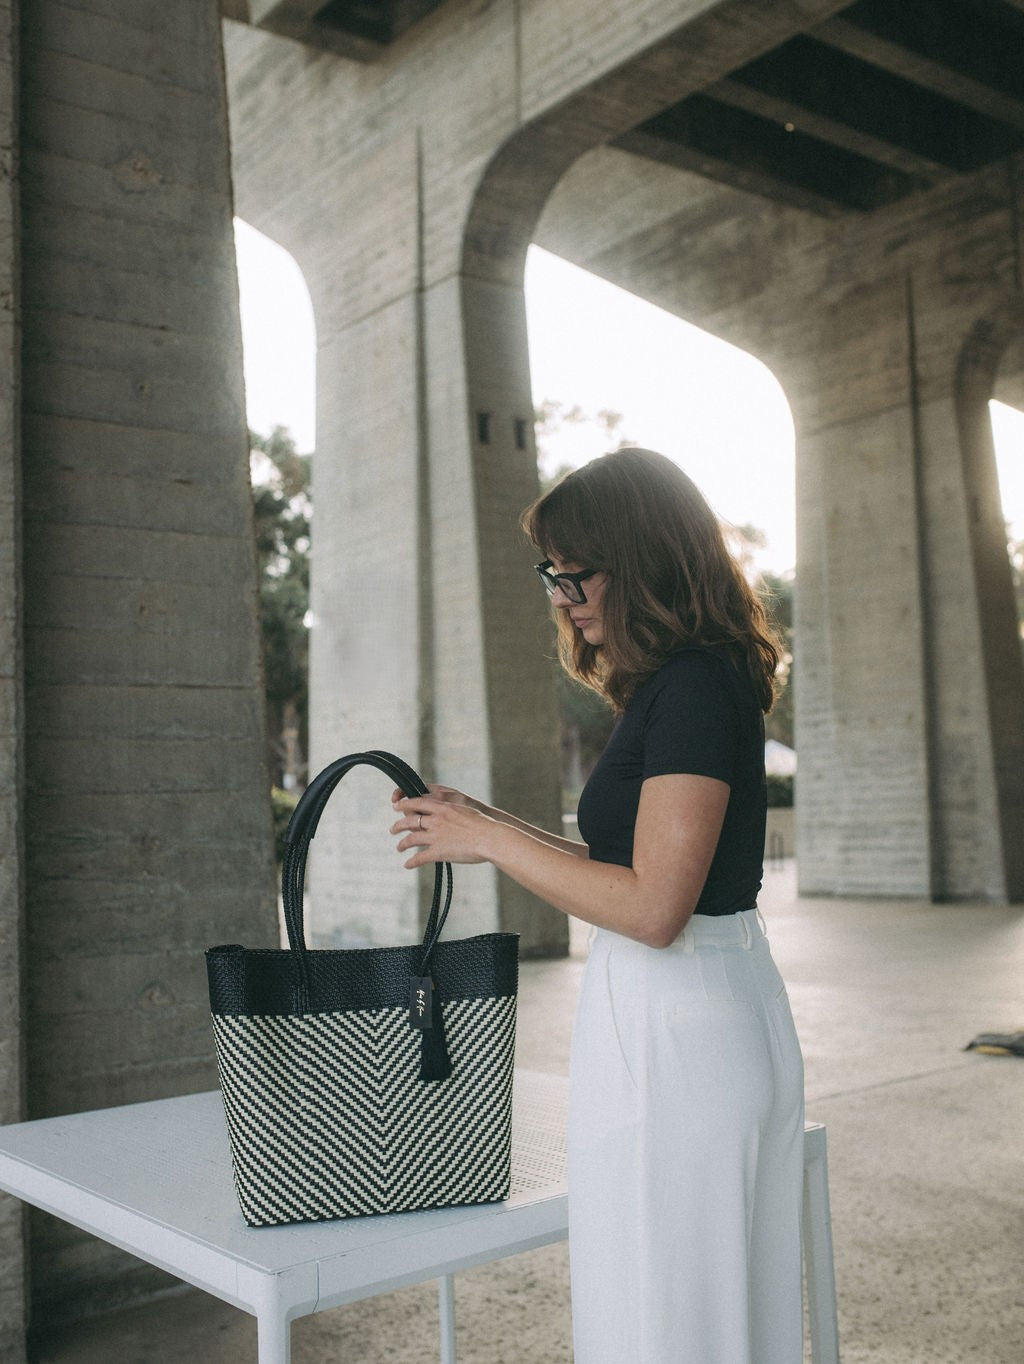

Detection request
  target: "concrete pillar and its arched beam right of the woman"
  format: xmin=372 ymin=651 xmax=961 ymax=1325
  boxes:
xmin=537 ymin=149 xmax=1024 ymax=902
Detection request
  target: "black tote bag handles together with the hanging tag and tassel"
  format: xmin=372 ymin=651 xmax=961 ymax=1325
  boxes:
xmin=281 ymin=749 xmax=454 ymax=1079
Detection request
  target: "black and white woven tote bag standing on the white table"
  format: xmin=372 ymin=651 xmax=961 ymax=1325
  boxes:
xmin=206 ymin=750 xmax=518 ymax=1226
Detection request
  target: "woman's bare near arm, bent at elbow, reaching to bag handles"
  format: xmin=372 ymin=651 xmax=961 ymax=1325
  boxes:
xmin=391 ymin=773 xmax=729 ymax=947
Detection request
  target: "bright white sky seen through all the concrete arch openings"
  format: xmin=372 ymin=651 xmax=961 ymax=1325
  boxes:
xmin=236 ymin=220 xmax=1024 ymax=573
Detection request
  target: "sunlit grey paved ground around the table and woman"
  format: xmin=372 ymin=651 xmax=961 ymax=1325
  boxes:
xmin=33 ymin=865 xmax=1024 ymax=1364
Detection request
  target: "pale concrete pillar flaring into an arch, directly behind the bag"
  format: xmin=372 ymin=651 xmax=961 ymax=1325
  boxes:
xmin=220 ymin=0 xmax=836 ymax=952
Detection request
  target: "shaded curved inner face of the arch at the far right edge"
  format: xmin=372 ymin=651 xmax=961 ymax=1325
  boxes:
xmin=956 ymin=295 xmax=1024 ymax=902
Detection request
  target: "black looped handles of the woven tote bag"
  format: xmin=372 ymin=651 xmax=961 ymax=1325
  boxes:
xmin=281 ymin=749 xmax=453 ymax=1026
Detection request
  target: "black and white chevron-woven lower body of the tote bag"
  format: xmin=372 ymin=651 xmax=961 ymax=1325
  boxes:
xmin=213 ymin=994 xmax=515 ymax=1226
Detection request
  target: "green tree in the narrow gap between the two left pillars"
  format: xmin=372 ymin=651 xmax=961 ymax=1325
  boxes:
xmin=250 ymin=427 xmax=312 ymax=790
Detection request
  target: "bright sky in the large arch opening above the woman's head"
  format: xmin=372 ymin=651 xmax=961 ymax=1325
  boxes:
xmin=526 ymin=247 xmax=796 ymax=570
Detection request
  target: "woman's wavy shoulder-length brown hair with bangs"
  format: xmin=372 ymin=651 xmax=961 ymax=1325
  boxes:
xmin=522 ymin=449 xmax=780 ymax=712
